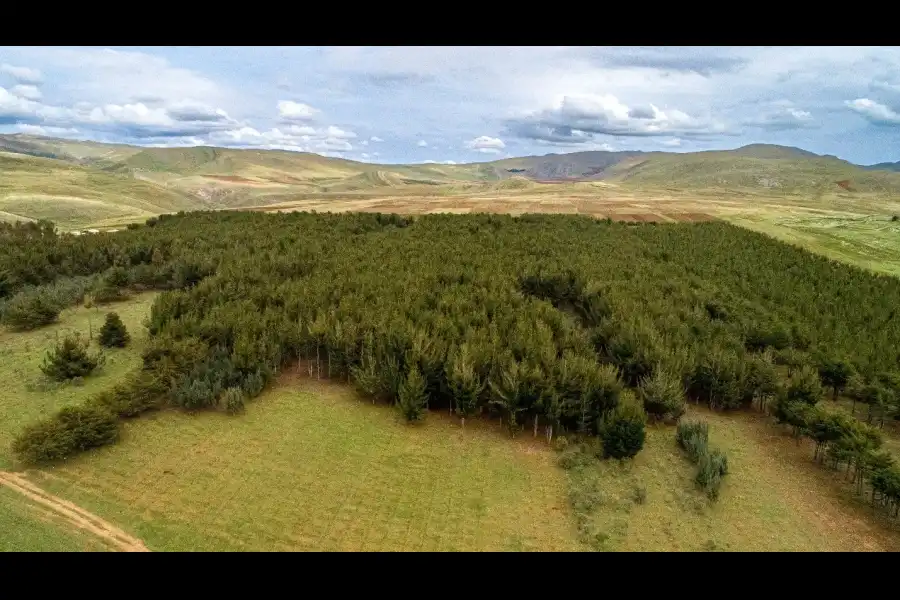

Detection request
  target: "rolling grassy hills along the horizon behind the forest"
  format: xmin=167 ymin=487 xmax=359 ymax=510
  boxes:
xmin=0 ymin=134 xmax=900 ymax=229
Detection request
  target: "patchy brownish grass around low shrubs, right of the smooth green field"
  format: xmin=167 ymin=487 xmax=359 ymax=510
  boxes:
xmin=568 ymin=407 xmax=900 ymax=551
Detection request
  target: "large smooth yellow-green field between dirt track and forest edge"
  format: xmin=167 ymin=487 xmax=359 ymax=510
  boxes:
xmin=22 ymin=380 xmax=579 ymax=551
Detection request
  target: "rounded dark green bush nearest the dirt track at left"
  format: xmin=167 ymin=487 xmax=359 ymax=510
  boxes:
xmin=12 ymin=405 xmax=119 ymax=464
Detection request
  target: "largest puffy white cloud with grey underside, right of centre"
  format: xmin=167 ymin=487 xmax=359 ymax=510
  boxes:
xmin=507 ymin=94 xmax=728 ymax=144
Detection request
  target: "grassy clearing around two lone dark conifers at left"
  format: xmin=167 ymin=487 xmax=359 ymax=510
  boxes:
xmin=0 ymin=294 xmax=153 ymax=470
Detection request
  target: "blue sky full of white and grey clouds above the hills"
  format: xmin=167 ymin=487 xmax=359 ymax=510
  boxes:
xmin=0 ymin=46 xmax=900 ymax=164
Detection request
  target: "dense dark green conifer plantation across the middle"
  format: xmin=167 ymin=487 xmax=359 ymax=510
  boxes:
xmin=10 ymin=213 xmax=900 ymax=468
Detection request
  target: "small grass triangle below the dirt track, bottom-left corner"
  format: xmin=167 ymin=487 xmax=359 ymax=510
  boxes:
xmin=0 ymin=486 xmax=108 ymax=552
